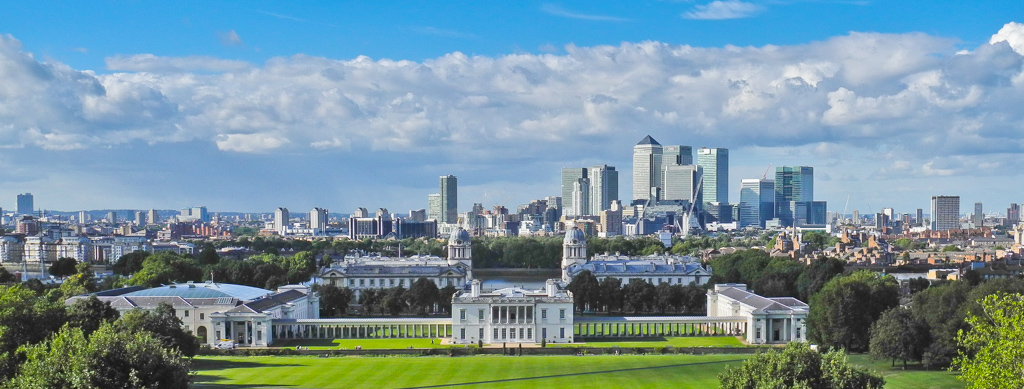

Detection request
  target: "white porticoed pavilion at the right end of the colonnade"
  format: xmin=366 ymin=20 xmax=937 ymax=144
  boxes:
xmin=708 ymin=284 xmax=809 ymax=344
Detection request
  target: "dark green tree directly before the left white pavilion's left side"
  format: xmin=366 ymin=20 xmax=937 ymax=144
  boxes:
xmin=115 ymin=303 xmax=199 ymax=356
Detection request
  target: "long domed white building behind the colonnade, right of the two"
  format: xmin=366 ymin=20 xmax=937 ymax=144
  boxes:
xmin=562 ymin=227 xmax=711 ymax=286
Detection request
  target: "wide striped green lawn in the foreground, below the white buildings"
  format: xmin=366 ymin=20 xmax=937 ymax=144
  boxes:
xmin=194 ymin=354 xmax=963 ymax=389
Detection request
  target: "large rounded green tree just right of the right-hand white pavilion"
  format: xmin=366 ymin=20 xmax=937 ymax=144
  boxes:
xmin=807 ymin=270 xmax=899 ymax=351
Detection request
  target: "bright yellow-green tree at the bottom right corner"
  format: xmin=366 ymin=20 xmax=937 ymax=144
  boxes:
xmin=953 ymin=293 xmax=1024 ymax=389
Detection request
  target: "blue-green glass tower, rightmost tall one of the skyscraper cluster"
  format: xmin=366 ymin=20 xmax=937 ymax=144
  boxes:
xmin=774 ymin=166 xmax=814 ymax=226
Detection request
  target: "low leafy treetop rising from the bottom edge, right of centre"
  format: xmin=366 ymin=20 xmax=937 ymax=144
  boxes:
xmin=718 ymin=342 xmax=885 ymax=389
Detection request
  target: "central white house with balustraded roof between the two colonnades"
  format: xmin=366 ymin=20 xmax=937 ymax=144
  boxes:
xmin=452 ymin=279 xmax=572 ymax=344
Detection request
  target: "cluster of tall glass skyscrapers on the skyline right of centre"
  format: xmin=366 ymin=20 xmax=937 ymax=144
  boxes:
xmin=560 ymin=135 xmax=827 ymax=236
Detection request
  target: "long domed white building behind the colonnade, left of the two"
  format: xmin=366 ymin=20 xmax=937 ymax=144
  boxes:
xmin=319 ymin=228 xmax=473 ymax=301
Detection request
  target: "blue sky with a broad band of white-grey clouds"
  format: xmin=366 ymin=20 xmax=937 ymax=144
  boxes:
xmin=0 ymin=0 xmax=1024 ymax=214
